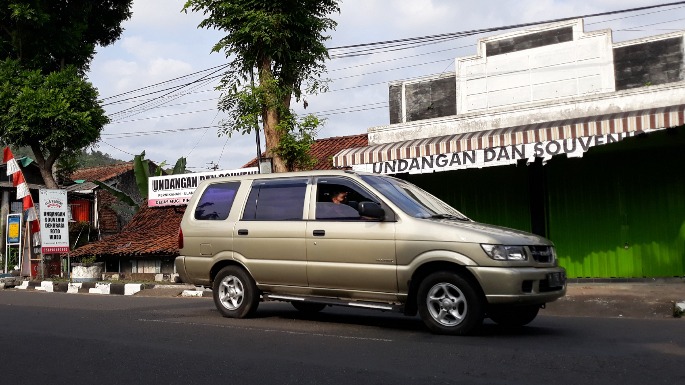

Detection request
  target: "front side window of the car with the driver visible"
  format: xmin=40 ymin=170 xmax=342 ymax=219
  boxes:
xmin=315 ymin=177 xmax=378 ymax=220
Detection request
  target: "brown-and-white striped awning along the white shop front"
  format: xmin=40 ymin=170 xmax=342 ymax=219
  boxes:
xmin=333 ymin=104 xmax=685 ymax=168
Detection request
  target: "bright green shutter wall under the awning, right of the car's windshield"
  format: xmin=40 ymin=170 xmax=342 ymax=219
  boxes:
xmin=545 ymin=129 xmax=685 ymax=278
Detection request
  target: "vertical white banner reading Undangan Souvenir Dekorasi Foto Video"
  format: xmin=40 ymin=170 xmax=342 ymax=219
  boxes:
xmin=39 ymin=189 xmax=69 ymax=254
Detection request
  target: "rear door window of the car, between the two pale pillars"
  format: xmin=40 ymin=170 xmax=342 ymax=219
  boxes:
xmin=243 ymin=178 xmax=307 ymax=221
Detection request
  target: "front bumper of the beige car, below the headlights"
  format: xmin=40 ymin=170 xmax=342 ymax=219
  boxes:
xmin=468 ymin=266 xmax=566 ymax=305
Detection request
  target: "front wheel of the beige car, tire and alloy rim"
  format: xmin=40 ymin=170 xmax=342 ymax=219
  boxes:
xmin=417 ymin=271 xmax=484 ymax=335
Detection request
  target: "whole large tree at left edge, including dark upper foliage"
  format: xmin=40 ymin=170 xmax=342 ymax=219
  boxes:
xmin=0 ymin=0 xmax=133 ymax=188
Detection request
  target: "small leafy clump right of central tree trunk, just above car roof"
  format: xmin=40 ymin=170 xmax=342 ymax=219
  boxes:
xmin=274 ymin=114 xmax=323 ymax=171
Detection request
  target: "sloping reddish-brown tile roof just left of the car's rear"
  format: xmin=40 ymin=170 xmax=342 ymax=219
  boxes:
xmin=71 ymin=206 xmax=185 ymax=257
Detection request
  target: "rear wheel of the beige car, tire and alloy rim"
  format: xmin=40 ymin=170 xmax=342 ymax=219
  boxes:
xmin=213 ymin=266 xmax=259 ymax=318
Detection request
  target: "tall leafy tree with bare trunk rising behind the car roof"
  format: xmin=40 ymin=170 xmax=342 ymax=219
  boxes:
xmin=183 ymin=0 xmax=340 ymax=172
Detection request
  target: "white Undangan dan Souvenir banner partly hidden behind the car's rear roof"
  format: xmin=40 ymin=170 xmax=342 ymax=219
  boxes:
xmin=147 ymin=167 xmax=259 ymax=207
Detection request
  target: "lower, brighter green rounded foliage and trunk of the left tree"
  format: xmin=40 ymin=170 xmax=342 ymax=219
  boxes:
xmin=0 ymin=60 xmax=109 ymax=188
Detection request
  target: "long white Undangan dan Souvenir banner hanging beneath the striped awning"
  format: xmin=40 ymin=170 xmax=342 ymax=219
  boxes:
xmin=352 ymin=130 xmax=657 ymax=174
